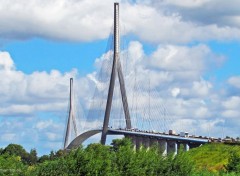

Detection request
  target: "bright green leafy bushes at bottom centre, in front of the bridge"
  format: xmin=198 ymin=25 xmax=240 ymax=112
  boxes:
xmin=29 ymin=139 xmax=193 ymax=176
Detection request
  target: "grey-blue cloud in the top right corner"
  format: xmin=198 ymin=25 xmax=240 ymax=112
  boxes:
xmin=151 ymin=0 xmax=240 ymax=28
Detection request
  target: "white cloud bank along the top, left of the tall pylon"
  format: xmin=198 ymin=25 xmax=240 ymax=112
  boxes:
xmin=0 ymin=0 xmax=113 ymax=41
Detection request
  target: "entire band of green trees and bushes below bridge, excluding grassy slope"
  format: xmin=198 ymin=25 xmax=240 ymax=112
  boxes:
xmin=0 ymin=139 xmax=240 ymax=176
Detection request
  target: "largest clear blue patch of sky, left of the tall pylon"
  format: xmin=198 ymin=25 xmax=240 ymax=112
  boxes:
xmin=3 ymin=38 xmax=106 ymax=74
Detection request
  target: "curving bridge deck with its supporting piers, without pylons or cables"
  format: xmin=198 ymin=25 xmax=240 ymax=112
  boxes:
xmin=66 ymin=128 xmax=209 ymax=154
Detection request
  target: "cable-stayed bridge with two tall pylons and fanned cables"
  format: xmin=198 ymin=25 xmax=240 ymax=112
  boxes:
xmin=64 ymin=3 xmax=209 ymax=153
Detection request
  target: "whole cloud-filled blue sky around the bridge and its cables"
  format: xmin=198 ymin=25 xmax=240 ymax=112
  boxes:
xmin=0 ymin=0 xmax=240 ymax=155
